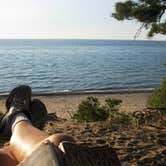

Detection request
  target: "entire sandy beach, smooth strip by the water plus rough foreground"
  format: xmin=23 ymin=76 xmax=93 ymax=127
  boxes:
xmin=0 ymin=92 xmax=166 ymax=166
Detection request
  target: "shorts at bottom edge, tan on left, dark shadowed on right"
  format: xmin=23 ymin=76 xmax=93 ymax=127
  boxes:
xmin=19 ymin=141 xmax=121 ymax=166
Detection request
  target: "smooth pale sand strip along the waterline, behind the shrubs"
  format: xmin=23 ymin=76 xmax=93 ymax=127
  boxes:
xmin=0 ymin=92 xmax=151 ymax=119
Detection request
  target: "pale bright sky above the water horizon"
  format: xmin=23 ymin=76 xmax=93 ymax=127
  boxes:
xmin=0 ymin=0 xmax=166 ymax=40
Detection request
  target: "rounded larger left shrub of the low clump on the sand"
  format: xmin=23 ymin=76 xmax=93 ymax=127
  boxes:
xmin=72 ymin=97 xmax=109 ymax=122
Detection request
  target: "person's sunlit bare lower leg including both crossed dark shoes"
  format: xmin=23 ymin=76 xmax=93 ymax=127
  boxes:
xmin=0 ymin=85 xmax=71 ymax=164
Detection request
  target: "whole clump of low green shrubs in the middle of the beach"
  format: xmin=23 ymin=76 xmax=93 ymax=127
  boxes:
xmin=72 ymin=97 xmax=135 ymax=124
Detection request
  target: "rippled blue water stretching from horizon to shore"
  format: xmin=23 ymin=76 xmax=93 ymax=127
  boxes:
xmin=0 ymin=40 xmax=166 ymax=92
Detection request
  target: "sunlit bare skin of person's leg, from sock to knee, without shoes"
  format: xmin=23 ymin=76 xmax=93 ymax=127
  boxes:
xmin=10 ymin=121 xmax=74 ymax=162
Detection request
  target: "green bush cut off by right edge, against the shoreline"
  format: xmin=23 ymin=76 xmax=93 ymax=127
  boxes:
xmin=147 ymin=78 xmax=166 ymax=109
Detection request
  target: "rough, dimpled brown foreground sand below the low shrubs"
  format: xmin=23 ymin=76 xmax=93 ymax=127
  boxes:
xmin=44 ymin=114 xmax=166 ymax=166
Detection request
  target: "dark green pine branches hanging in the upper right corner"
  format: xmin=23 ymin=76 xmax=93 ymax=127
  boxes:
xmin=112 ymin=0 xmax=166 ymax=38
